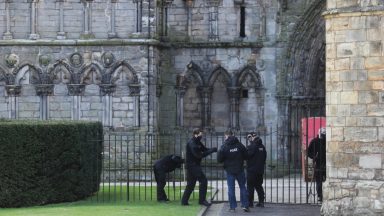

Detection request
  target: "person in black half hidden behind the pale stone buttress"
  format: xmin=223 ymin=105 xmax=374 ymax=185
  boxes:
xmin=307 ymin=128 xmax=326 ymax=202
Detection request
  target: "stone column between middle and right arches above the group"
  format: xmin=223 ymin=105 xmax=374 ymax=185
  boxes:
xmin=227 ymin=87 xmax=240 ymax=130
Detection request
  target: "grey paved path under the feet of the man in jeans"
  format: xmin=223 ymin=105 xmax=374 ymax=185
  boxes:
xmin=202 ymin=202 xmax=320 ymax=216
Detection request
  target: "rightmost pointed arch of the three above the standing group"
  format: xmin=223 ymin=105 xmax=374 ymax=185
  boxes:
xmin=236 ymin=65 xmax=263 ymax=88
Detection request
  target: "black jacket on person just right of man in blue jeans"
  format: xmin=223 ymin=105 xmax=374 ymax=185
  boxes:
xmin=247 ymin=138 xmax=267 ymax=174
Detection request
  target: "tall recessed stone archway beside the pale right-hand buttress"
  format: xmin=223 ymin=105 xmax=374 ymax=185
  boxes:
xmin=280 ymin=0 xmax=326 ymax=165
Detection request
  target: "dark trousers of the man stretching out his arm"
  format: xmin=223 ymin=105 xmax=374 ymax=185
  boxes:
xmin=181 ymin=166 xmax=208 ymax=205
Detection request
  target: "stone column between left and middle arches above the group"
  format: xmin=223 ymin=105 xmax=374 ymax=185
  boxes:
xmin=197 ymin=86 xmax=213 ymax=131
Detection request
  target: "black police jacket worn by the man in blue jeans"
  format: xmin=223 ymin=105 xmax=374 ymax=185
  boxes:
xmin=217 ymin=136 xmax=247 ymax=175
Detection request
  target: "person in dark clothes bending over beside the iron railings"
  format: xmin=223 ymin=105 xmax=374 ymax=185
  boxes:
xmin=153 ymin=154 xmax=184 ymax=202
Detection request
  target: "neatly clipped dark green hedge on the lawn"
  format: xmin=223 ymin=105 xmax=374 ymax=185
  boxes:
xmin=0 ymin=120 xmax=103 ymax=207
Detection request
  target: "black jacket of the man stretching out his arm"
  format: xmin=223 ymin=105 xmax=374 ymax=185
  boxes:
xmin=185 ymin=137 xmax=217 ymax=167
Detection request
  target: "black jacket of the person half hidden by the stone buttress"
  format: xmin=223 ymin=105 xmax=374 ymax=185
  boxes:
xmin=307 ymin=136 xmax=326 ymax=170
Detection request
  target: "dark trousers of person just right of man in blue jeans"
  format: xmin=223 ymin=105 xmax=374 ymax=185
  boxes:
xmin=247 ymin=172 xmax=265 ymax=205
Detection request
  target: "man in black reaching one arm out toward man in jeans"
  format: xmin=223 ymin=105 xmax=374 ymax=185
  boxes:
xmin=181 ymin=129 xmax=217 ymax=206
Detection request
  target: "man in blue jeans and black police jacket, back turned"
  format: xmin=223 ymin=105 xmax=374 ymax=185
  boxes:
xmin=217 ymin=130 xmax=249 ymax=212
